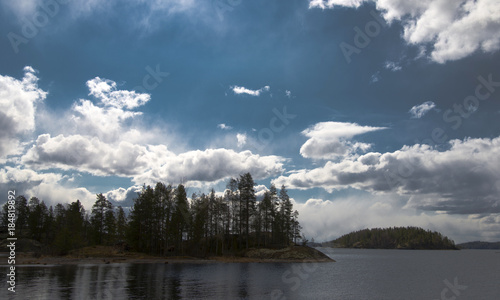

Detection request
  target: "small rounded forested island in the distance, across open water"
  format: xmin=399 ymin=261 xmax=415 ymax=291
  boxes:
xmin=323 ymin=227 xmax=458 ymax=250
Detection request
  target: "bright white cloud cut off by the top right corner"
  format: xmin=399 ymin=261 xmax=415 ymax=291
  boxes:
xmin=309 ymin=0 xmax=500 ymax=63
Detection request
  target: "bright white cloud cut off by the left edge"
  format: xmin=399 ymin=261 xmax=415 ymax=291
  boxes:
xmin=0 ymin=67 xmax=47 ymax=162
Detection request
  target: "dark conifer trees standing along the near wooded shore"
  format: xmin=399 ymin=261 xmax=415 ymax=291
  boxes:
xmin=1 ymin=173 xmax=301 ymax=256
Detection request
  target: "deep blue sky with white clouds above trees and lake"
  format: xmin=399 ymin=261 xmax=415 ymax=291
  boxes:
xmin=0 ymin=0 xmax=500 ymax=243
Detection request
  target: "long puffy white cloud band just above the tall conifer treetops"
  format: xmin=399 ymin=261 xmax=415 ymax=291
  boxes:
xmin=22 ymin=134 xmax=284 ymax=184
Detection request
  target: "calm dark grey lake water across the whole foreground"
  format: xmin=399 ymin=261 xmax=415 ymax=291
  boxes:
xmin=0 ymin=248 xmax=500 ymax=300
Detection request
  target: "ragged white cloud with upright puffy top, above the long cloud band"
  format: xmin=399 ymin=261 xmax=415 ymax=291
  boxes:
xmin=36 ymin=78 xmax=167 ymax=145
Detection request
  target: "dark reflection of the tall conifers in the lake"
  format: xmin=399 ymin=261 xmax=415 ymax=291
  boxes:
xmin=0 ymin=263 xmax=283 ymax=299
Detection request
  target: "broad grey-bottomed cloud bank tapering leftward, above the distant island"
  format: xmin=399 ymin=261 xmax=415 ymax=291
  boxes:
xmin=273 ymin=137 xmax=500 ymax=214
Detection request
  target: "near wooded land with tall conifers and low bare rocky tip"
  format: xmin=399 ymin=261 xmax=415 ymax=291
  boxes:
xmin=0 ymin=173 xmax=333 ymax=264
